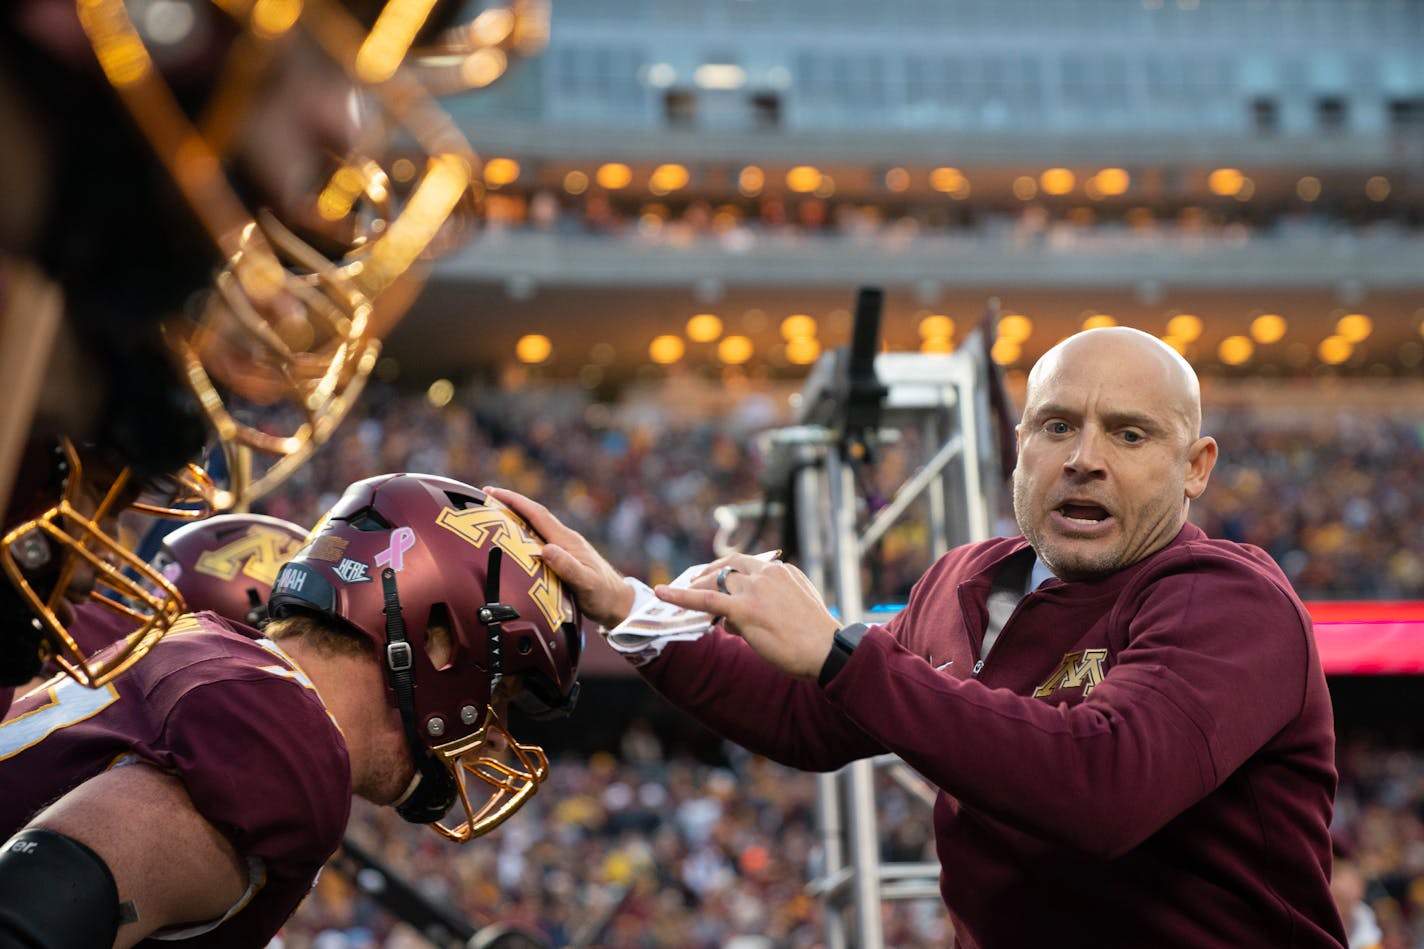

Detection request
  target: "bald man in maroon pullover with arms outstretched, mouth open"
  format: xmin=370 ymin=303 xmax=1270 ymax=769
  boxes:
xmin=496 ymin=328 xmax=1344 ymax=949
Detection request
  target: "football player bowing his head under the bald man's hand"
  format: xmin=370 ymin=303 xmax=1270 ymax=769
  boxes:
xmin=0 ymin=475 xmax=582 ymax=949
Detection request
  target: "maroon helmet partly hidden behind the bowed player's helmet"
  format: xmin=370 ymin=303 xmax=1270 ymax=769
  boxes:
xmin=151 ymin=514 xmax=306 ymax=627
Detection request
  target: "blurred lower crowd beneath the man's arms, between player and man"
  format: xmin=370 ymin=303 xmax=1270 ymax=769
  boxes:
xmin=283 ymin=726 xmax=948 ymax=949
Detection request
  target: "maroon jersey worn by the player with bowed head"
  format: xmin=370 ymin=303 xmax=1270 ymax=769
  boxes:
xmin=0 ymin=613 xmax=352 ymax=948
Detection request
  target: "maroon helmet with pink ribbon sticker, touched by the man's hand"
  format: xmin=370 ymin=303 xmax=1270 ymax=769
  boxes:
xmin=269 ymin=475 xmax=582 ymax=841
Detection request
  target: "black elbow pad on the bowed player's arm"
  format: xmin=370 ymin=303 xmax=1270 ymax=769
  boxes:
xmin=0 ymin=828 xmax=120 ymax=949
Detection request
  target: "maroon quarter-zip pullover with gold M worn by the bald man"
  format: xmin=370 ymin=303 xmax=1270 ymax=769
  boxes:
xmin=639 ymin=526 xmax=1344 ymax=949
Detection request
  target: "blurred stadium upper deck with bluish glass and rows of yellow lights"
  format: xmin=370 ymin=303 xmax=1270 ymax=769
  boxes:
xmin=370 ymin=0 xmax=1424 ymax=385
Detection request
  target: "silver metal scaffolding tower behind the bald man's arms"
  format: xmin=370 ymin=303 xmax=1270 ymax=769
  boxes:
xmin=722 ymin=300 xmax=1004 ymax=949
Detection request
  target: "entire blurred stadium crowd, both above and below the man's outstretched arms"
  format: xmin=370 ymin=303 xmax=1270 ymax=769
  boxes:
xmin=244 ymin=385 xmax=1424 ymax=949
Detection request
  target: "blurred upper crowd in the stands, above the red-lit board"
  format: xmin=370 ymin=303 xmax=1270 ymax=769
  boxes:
xmin=258 ymin=373 xmax=1424 ymax=600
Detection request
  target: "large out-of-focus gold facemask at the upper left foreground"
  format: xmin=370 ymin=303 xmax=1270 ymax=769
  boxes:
xmin=77 ymin=0 xmax=478 ymax=509
